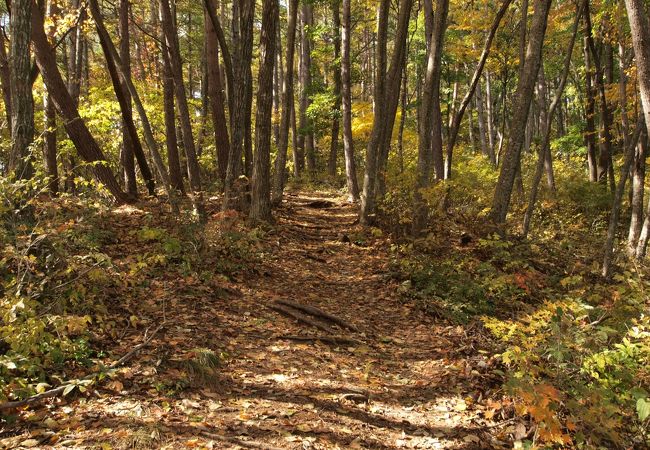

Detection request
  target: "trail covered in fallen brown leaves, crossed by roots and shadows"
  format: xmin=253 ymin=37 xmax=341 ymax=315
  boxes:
xmin=2 ymin=192 xmax=512 ymax=449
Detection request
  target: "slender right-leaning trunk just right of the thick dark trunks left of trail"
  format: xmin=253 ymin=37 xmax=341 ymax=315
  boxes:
xmin=273 ymin=0 xmax=298 ymax=205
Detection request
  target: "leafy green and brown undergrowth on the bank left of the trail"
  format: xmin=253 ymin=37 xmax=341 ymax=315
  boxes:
xmin=0 ymin=179 xmax=262 ymax=408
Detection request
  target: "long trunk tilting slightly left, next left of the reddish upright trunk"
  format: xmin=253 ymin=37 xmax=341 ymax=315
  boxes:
xmin=160 ymin=0 xmax=206 ymax=220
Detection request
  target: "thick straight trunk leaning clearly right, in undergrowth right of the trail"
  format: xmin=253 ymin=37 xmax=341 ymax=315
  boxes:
xmin=490 ymin=0 xmax=552 ymax=223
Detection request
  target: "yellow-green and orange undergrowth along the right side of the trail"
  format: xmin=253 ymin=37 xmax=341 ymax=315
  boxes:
xmin=384 ymin=151 xmax=650 ymax=448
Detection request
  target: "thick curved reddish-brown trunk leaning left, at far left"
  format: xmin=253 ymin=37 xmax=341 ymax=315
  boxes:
xmin=30 ymin=0 xmax=131 ymax=203
